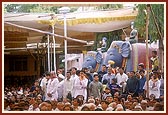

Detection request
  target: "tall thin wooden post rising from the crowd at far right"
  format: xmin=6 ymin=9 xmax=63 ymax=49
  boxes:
xmin=146 ymin=4 xmax=150 ymax=98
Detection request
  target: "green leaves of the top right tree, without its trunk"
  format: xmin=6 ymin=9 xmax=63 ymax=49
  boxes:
xmin=135 ymin=4 xmax=164 ymax=42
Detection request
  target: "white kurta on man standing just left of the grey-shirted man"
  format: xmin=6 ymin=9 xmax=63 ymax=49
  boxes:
xmin=73 ymin=77 xmax=88 ymax=100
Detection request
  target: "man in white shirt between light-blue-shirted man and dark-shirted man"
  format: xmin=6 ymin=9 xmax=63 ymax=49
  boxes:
xmin=116 ymin=67 xmax=128 ymax=93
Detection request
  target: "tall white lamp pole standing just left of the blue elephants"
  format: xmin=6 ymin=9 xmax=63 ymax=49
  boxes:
xmin=64 ymin=13 xmax=67 ymax=76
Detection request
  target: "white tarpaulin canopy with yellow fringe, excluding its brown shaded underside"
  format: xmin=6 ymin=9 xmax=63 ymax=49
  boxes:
xmin=4 ymin=8 xmax=137 ymax=32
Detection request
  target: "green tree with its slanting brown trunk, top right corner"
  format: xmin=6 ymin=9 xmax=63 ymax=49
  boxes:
xmin=135 ymin=4 xmax=165 ymax=72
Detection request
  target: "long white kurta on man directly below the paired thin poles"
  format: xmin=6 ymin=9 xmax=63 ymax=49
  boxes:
xmin=45 ymin=78 xmax=59 ymax=101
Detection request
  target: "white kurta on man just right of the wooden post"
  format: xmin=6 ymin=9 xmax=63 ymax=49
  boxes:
xmin=149 ymin=80 xmax=160 ymax=98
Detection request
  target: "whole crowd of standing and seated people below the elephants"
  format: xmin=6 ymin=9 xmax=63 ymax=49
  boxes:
xmin=4 ymin=50 xmax=164 ymax=111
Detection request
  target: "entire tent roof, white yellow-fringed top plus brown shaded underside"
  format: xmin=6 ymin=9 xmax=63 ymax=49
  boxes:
xmin=4 ymin=8 xmax=137 ymax=54
